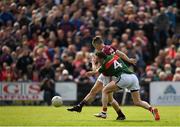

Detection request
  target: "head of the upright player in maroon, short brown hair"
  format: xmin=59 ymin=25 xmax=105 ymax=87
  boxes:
xmin=92 ymin=36 xmax=104 ymax=51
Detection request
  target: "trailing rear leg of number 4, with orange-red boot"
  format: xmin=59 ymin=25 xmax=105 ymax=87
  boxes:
xmin=131 ymin=91 xmax=160 ymax=120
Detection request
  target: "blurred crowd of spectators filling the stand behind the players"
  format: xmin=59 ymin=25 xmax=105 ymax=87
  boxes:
xmin=0 ymin=0 xmax=180 ymax=84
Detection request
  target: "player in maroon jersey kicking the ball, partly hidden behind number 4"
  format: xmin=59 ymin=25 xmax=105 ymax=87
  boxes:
xmin=67 ymin=36 xmax=136 ymax=120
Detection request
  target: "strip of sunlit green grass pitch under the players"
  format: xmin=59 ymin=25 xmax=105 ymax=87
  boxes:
xmin=0 ymin=106 xmax=180 ymax=126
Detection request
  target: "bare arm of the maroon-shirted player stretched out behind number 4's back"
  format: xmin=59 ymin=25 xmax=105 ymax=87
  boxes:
xmin=116 ymin=50 xmax=137 ymax=65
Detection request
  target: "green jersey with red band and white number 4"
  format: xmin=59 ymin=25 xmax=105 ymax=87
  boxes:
xmin=99 ymin=55 xmax=133 ymax=77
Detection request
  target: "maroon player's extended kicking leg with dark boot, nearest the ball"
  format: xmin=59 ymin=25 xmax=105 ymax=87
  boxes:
xmin=67 ymin=81 xmax=103 ymax=112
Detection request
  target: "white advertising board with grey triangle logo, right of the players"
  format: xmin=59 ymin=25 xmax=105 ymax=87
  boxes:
xmin=150 ymin=81 xmax=180 ymax=106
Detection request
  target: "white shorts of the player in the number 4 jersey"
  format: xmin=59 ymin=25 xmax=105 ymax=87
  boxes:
xmin=116 ymin=74 xmax=140 ymax=91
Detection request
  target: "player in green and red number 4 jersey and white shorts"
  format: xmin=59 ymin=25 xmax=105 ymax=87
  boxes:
xmin=94 ymin=52 xmax=160 ymax=120
